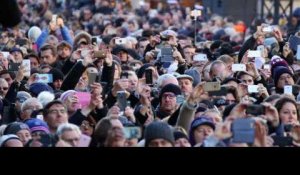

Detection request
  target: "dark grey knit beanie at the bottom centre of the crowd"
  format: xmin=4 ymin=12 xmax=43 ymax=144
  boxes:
xmin=145 ymin=121 xmax=175 ymax=147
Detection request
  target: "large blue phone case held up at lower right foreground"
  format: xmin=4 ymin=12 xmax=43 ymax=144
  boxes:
xmin=231 ymin=118 xmax=255 ymax=144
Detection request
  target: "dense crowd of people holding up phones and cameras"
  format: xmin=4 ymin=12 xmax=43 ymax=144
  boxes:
xmin=0 ymin=0 xmax=300 ymax=147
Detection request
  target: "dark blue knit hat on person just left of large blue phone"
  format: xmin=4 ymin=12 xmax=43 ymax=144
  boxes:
xmin=189 ymin=115 xmax=215 ymax=146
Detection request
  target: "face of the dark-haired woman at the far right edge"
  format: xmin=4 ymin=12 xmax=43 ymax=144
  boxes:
xmin=279 ymin=102 xmax=299 ymax=124
